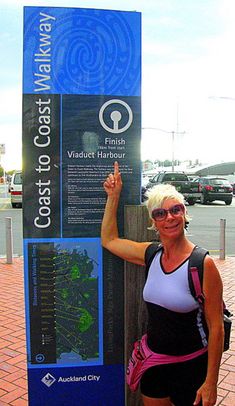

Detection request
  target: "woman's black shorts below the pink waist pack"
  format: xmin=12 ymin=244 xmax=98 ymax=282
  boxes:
xmin=140 ymin=353 xmax=207 ymax=406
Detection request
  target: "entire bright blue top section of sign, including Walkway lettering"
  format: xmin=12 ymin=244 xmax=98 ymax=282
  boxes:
xmin=23 ymin=7 xmax=141 ymax=96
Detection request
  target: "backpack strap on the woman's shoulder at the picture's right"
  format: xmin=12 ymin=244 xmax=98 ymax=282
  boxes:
xmin=188 ymin=246 xmax=209 ymax=304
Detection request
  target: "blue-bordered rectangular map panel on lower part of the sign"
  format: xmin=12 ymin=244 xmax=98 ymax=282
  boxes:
xmin=28 ymin=238 xmax=103 ymax=366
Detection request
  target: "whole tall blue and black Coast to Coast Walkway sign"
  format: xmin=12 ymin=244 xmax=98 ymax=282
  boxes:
xmin=23 ymin=7 xmax=141 ymax=406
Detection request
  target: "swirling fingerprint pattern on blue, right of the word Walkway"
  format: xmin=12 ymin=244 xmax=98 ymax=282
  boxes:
xmin=23 ymin=8 xmax=140 ymax=95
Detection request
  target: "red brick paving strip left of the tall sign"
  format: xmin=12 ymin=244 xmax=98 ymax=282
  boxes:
xmin=0 ymin=258 xmax=28 ymax=406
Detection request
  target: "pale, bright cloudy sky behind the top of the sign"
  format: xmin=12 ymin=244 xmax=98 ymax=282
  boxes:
xmin=0 ymin=0 xmax=235 ymax=171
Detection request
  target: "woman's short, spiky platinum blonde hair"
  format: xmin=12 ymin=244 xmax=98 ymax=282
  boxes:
xmin=145 ymin=184 xmax=190 ymax=230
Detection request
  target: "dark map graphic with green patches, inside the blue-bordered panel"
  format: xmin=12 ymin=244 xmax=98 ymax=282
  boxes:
xmin=55 ymin=244 xmax=102 ymax=364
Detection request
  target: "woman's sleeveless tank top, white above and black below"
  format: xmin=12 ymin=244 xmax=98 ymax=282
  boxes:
xmin=143 ymin=250 xmax=208 ymax=355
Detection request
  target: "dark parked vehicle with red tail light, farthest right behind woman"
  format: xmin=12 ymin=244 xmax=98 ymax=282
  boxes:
xmin=198 ymin=176 xmax=233 ymax=205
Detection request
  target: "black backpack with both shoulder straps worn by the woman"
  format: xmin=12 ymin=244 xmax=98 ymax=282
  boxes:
xmin=145 ymin=243 xmax=232 ymax=351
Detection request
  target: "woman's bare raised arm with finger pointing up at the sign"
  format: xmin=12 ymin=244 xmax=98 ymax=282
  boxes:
xmin=101 ymin=162 xmax=150 ymax=265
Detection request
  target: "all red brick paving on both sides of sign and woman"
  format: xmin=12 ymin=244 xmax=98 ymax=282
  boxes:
xmin=0 ymin=257 xmax=235 ymax=406
